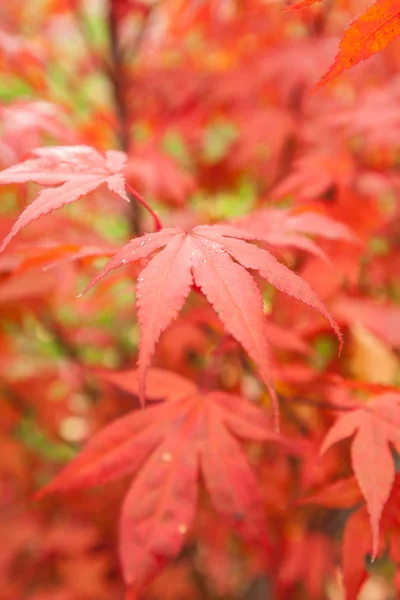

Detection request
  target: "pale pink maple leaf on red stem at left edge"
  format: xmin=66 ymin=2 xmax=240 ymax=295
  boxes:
xmin=0 ymin=146 xmax=129 ymax=252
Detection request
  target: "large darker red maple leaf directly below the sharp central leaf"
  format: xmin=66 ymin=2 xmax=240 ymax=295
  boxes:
xmin=40 ymin=372 xmax=283 ymax=588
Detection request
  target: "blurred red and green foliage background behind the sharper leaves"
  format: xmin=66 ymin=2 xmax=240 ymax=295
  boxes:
xmin=0 ymin=0 xmax=400 ymax=600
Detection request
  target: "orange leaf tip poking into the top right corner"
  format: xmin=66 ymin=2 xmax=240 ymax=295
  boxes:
xmin=315 ymin=0 xmax=400 ymax=89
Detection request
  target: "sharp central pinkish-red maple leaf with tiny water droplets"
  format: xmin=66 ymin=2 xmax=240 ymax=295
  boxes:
xmin=85 ymin=225 xmax=341 ymax=408
